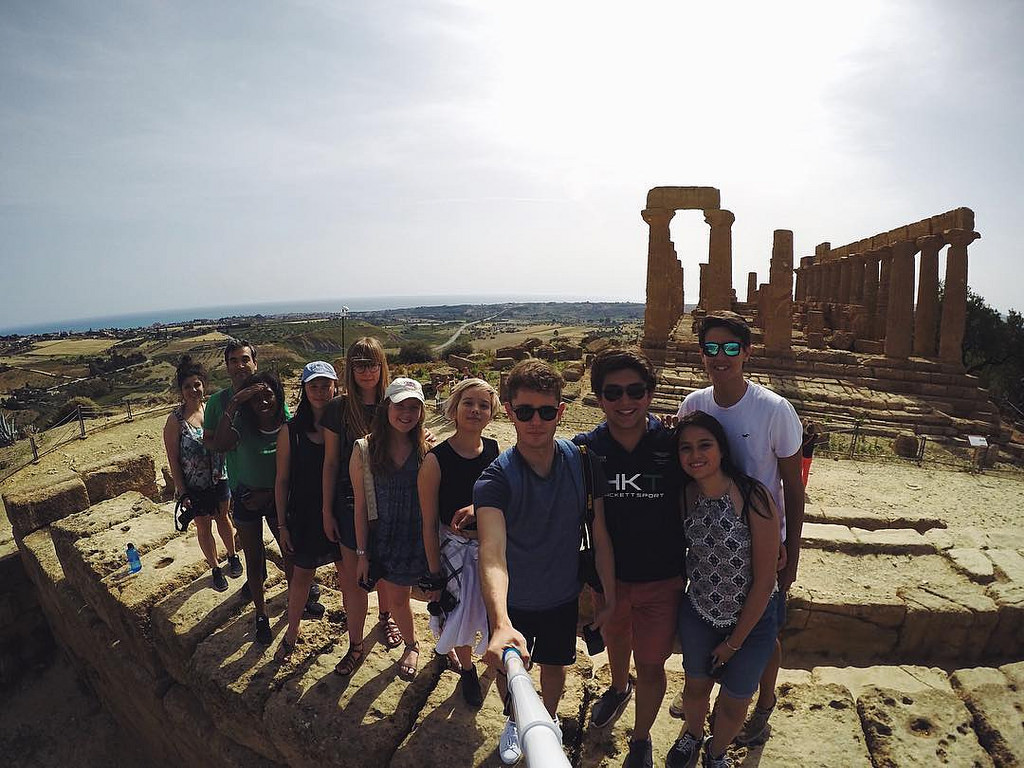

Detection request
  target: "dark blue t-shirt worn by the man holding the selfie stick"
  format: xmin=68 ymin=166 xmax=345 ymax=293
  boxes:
xmin=473 ymin=441 xmax=606 ymax=610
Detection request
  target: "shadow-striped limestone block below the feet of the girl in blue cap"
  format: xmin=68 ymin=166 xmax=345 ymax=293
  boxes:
xmin=188 ymin=585 xmax=290 ymax=765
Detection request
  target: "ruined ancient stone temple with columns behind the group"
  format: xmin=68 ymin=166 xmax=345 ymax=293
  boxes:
xmin=642 ymin=186 xmax=1009 ymax=443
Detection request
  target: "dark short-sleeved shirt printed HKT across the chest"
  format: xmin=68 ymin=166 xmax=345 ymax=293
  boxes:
xmin=572 ymin=415 xmax=686 ymax=582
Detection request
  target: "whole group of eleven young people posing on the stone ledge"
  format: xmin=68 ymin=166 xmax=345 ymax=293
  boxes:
xmin=165 ymin=312 xmax=804 ymax=768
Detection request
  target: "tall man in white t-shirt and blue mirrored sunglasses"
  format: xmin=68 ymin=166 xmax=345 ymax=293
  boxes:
xmin=674 ymin=311 xmax=804 ymax=745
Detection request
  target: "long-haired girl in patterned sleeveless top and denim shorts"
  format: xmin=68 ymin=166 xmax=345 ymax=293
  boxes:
xmin=668 ymin=411 xmax=779 ymax=767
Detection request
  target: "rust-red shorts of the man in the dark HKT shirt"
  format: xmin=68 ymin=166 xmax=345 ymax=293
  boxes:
xmin=603 ymin=577 xmax=683 ymax=665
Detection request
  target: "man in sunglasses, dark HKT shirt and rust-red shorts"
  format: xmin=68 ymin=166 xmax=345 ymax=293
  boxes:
xmin=573 ymin=349 xmax=684 ymax=768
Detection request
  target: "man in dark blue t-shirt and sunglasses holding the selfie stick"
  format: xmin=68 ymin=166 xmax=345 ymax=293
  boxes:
xmin=473 ymin=359 xmax=615 ymax=765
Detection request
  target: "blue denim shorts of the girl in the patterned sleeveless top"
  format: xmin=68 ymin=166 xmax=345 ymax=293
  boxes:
xmin=679 ymin=592 xmax=784 ymax=698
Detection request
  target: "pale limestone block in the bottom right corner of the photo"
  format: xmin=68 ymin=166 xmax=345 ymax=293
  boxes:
xmin=950 ymin=668 xmax=1024 ymax=766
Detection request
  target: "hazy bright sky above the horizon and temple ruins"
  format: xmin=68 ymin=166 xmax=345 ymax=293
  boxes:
xmin=0 ymin=0 xmax=1024 ymax=328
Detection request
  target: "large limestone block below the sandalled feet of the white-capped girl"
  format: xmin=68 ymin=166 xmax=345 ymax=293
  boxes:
xmin=264 ymin=603 xmax=448 ymax=767
